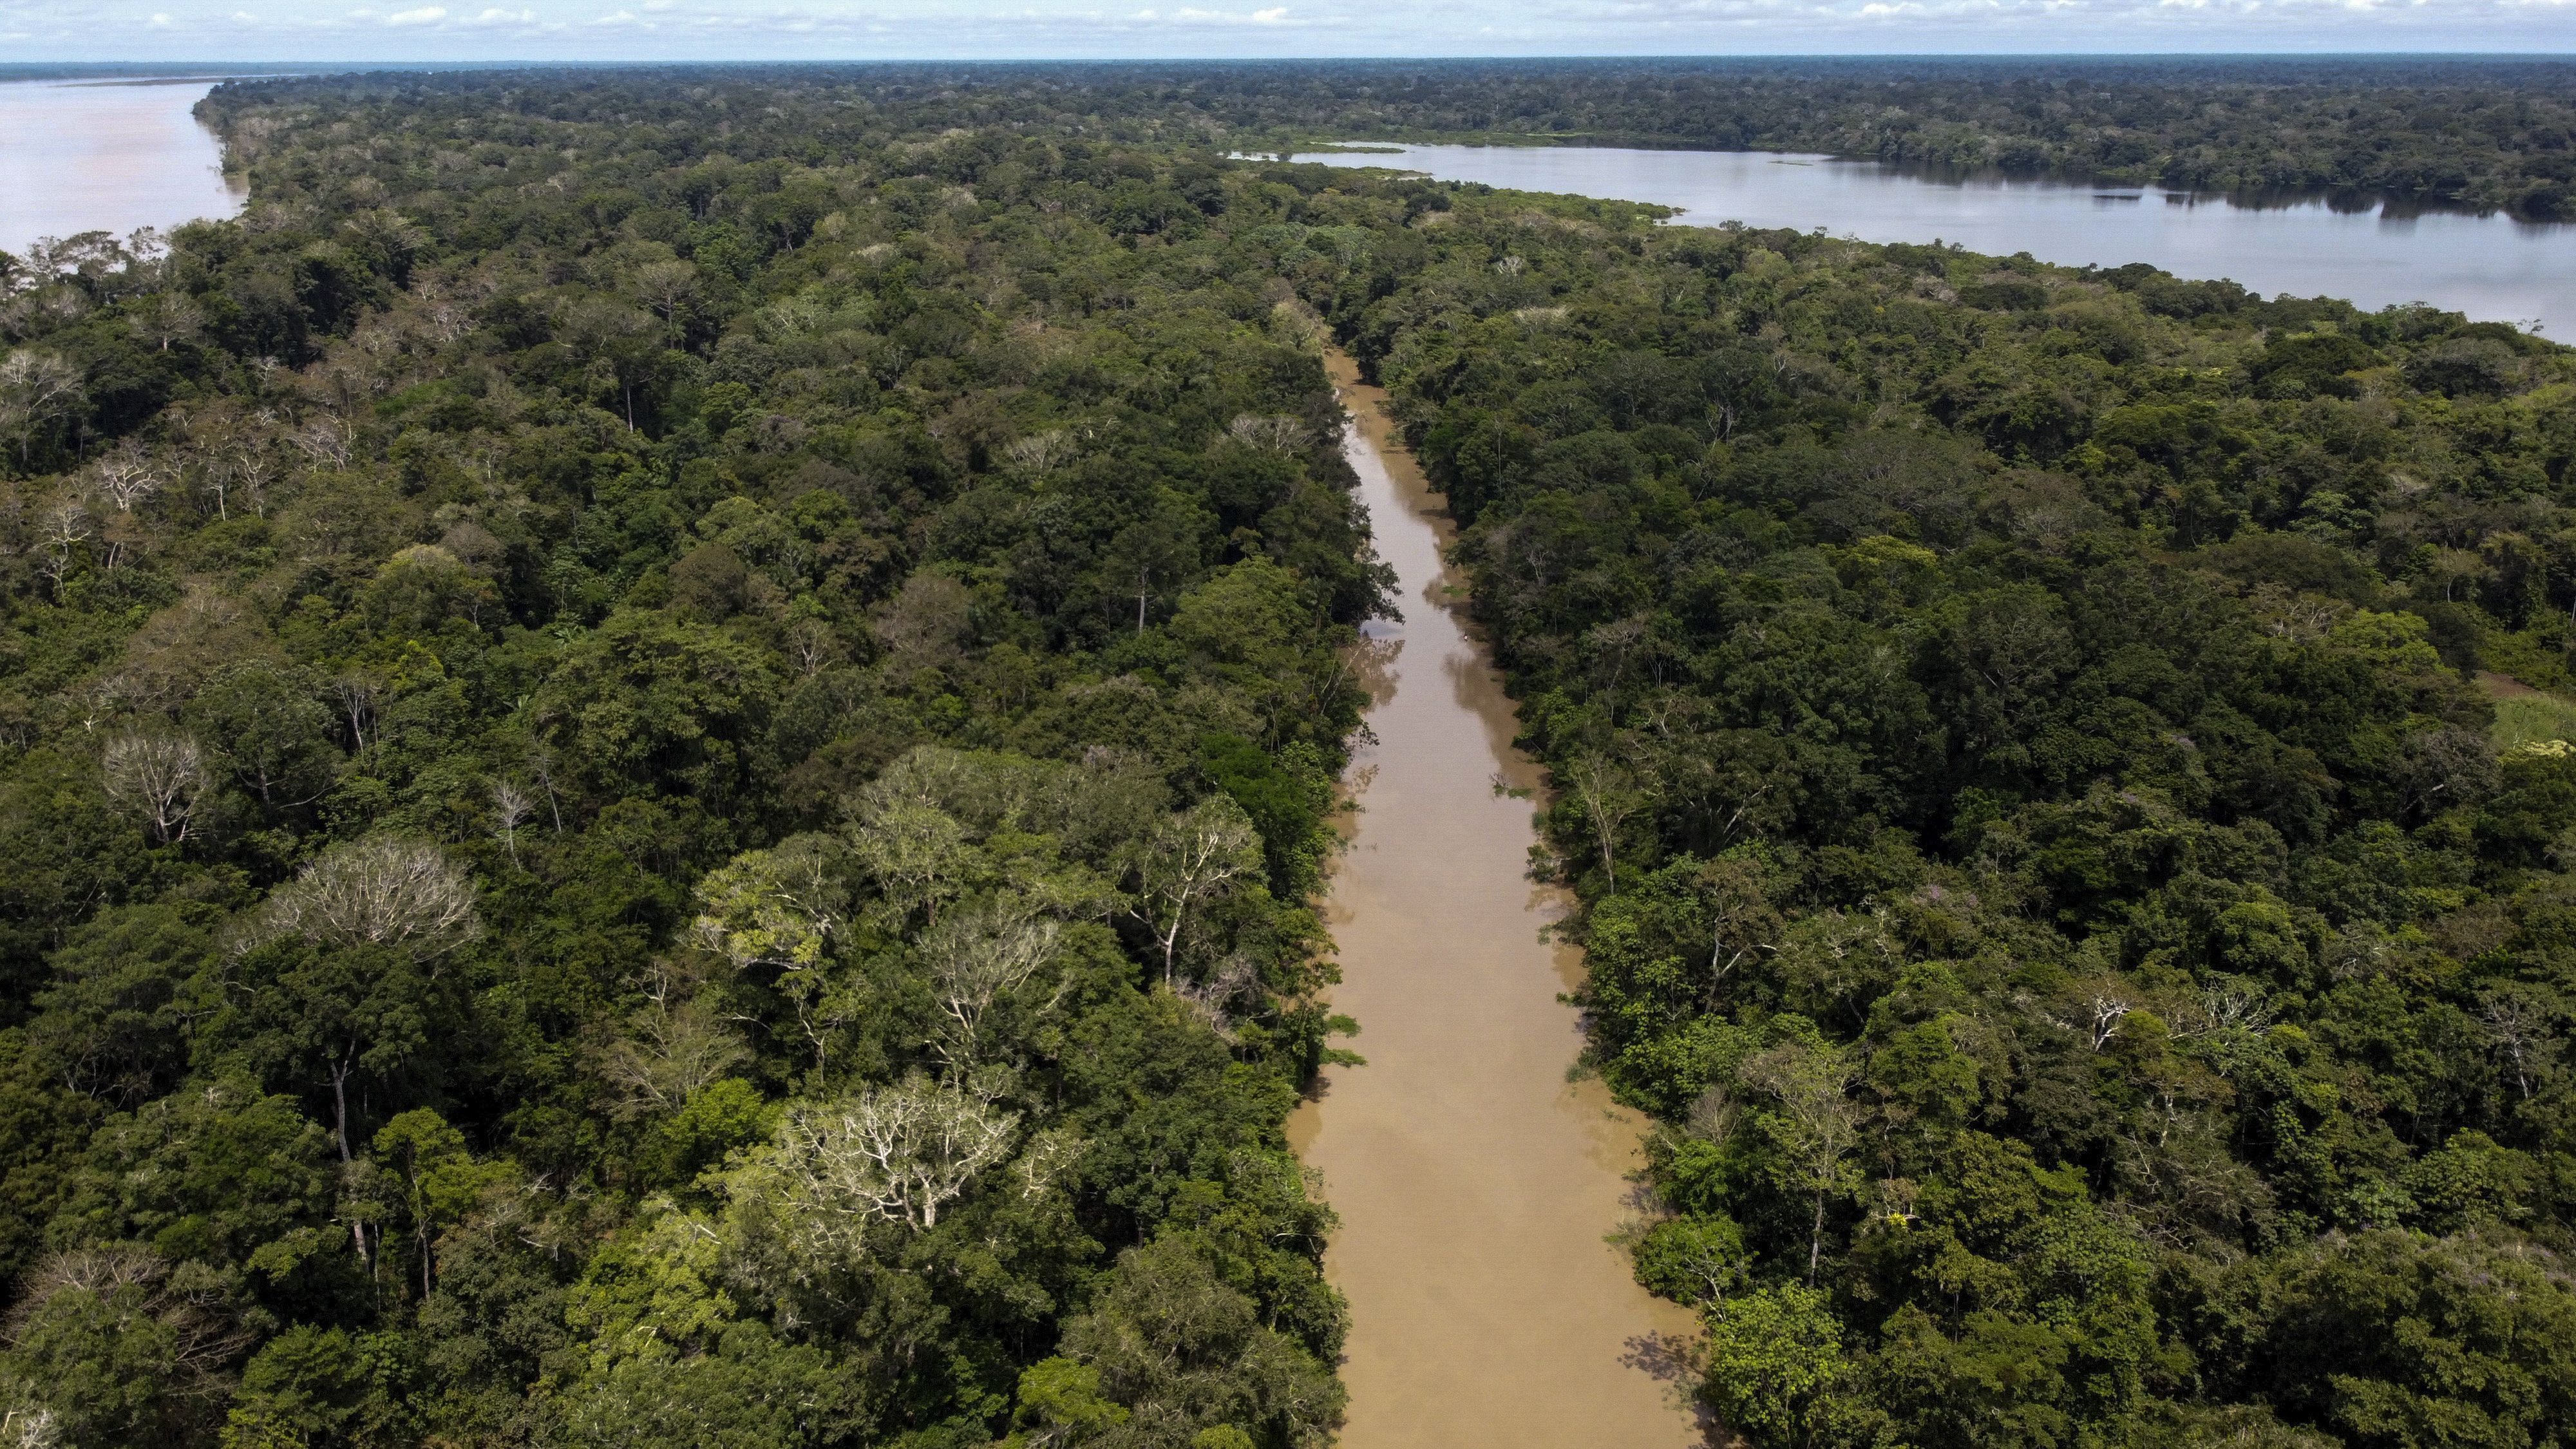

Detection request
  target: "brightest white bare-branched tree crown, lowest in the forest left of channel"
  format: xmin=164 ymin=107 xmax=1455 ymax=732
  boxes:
xmin=775 ymin=1077 xmax=1018 ymax=1235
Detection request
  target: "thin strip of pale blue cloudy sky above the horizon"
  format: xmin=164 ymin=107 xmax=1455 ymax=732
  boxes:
xmin=0 ymin=0 xmax=2576 ymax=62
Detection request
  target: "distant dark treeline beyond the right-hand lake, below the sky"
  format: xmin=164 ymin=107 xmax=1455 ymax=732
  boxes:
xmin=256 ymin=57 xmax=2576 ymax=219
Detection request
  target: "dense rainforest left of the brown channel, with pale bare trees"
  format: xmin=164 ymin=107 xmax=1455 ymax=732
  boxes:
xmin=0 ymin=77 xmax=1383 ymax=1449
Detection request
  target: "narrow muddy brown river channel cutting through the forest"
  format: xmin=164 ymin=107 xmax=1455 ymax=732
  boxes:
xmin=1288 ymin=343 xmax=1705 ymax=1449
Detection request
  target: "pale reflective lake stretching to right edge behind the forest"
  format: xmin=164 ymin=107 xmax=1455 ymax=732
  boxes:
xmin=1296 ymin=147 xmax=2576 ymax=343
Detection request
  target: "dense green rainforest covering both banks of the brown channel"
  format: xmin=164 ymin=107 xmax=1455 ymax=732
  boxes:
xmin=0 ymin=67 xmax=2576 ymax=1449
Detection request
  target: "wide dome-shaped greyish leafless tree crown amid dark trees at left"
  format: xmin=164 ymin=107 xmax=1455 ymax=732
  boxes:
xmin=242 ymin=835 xmax=482 ymax=961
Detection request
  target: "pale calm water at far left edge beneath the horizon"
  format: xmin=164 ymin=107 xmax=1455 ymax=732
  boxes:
xmin=0 ymin=80 xmax=242 ymax=252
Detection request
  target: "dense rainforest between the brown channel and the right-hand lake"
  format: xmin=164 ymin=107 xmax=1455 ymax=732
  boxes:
xmin=1316 ymin=110 xmax=2576 ymax=1449
